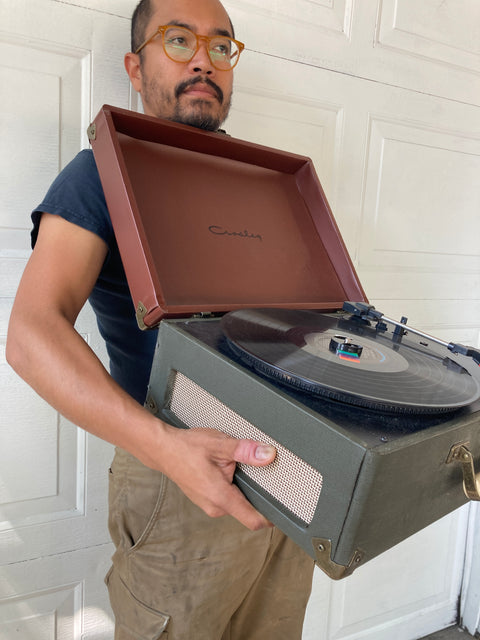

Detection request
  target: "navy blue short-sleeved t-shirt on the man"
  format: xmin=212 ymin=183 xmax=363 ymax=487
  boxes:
xmin=32 ymin=150 xmax=157 ymax=404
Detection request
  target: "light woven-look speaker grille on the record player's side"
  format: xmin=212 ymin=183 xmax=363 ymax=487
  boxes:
xmin=168 ymin=372 xmax=323 ymax=524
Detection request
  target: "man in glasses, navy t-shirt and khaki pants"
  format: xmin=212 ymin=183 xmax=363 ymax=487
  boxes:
xmin=7 ymin=0 xmax=313 ymax=640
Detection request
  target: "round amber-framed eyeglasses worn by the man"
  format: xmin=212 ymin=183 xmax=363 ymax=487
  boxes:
xmin=135 ymin=24 xmax=245 ymax=71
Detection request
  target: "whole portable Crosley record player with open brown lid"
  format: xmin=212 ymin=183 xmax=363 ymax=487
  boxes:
xmin=89 ymin=106 xmax=480 ymax=579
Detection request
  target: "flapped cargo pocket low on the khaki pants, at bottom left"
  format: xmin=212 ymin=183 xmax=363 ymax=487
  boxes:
xmin=105 ymin=568 xmax=170 ymax=640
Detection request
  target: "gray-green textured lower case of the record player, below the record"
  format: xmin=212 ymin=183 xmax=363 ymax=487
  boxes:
xmin=148 ymin=319 xmax=480 ymax=579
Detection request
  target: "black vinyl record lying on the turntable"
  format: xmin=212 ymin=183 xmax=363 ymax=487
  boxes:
xmin=222 ymin=309 xmax=480 ymax=413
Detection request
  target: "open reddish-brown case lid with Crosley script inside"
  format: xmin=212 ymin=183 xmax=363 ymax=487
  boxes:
xmin=89 ymin=106 xmax=366 ymax=327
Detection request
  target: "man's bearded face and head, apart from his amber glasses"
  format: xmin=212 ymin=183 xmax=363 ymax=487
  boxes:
xmin=125 ymin=0 xmax=233 ymax=131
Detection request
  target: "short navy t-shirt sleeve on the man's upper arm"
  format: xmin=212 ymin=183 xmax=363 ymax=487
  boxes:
xmin=31 ymin=149 xmax=113 ymax=248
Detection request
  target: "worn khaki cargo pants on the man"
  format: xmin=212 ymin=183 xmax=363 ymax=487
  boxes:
xmin=106 ymin=450 xmax=314 ymax=640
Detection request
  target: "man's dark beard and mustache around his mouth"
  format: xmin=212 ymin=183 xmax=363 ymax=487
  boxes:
xmin=142 ymin=76 xmax=231 ymax=131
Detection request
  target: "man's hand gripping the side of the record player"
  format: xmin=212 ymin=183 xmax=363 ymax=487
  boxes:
xmin=152 ymin=425 xmax=276 ymax=531
